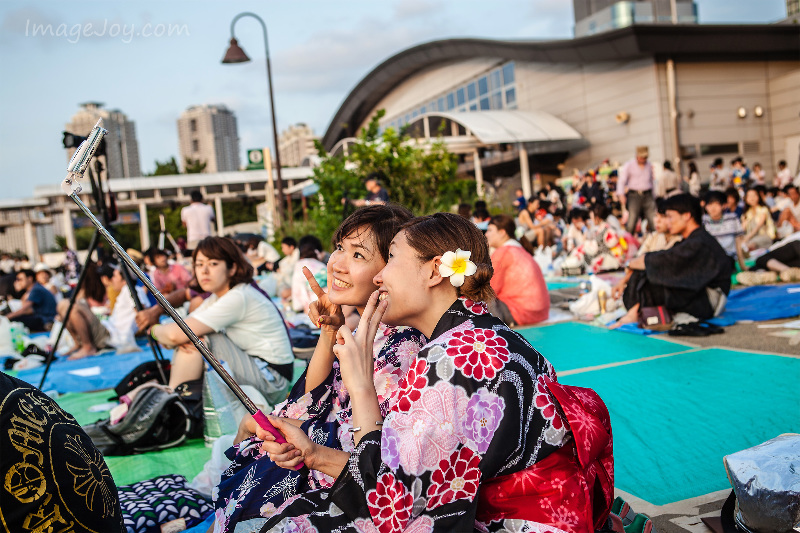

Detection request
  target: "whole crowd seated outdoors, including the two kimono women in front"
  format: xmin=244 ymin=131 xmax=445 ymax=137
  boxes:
xmin=0 ymin=152 xmax=800 ymax=533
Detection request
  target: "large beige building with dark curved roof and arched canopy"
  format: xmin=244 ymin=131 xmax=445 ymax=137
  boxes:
xmin=322 ymin=24 xmax=800 ymax=197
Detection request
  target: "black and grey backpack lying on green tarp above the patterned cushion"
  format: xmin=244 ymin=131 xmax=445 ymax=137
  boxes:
xmin=83 ymin=386 xmax=197 ymax=455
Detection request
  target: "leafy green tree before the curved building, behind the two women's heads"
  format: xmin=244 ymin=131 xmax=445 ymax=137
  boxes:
xmin=311 ymin=110 xmax=468 ymax=242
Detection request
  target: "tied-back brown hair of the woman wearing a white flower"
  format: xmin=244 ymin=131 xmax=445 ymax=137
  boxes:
xmin=401 ymin=213 xmax=495 ymax=302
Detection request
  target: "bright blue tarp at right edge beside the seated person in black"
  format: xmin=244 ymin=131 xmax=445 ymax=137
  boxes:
xmin=708 ymin=283 xmax=800 ymax=326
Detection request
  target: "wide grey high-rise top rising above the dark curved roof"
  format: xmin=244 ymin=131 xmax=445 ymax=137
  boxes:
xmin=572 ymin=0 xmax=696 ymax=37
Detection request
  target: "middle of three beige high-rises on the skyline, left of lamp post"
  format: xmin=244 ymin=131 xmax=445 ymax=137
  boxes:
xmin=178 ymin=105 xmax=239 ymax=173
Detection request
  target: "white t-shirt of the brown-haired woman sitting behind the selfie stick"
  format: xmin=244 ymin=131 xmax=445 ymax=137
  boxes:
xmin=189 ymin=283 xmax=294 ymax=365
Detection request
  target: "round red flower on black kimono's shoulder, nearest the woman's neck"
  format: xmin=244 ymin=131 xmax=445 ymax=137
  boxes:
xmin=447 ymin=328 xmax=509 ymax=379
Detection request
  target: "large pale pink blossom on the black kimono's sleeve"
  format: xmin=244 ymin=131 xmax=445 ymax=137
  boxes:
xmin=392 ymin=381 xmax=468 ymax=475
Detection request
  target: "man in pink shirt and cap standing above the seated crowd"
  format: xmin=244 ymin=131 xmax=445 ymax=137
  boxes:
xmin=617 ymin=146 xmax=656 ymax=233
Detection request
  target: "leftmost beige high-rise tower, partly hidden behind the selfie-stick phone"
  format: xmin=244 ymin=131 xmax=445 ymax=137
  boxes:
xmin=64 ymin=102 xmax=142 ymax=179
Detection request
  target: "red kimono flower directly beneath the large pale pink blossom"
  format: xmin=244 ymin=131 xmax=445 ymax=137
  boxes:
xmin=426 ymin=447 xmax=481 ymax=509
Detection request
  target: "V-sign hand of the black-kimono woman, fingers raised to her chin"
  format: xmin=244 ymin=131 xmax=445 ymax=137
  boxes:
xmin=333 ymin=291 xmax=388 ymax=395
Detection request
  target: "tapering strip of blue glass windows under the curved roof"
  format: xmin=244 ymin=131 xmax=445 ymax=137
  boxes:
xmin=382 ymin=61 xmax=517 ymax=130
